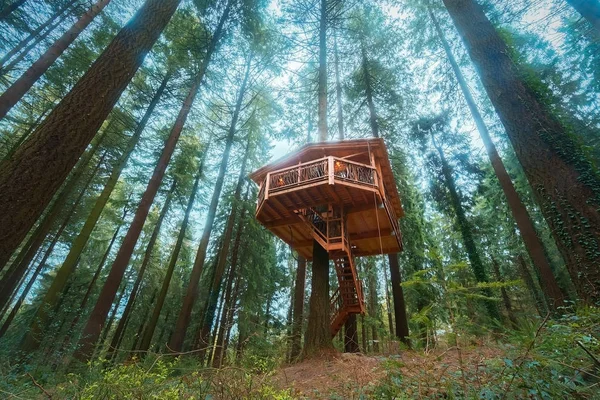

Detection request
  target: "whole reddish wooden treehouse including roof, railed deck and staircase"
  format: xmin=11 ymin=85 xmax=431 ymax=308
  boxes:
xmin=250 ymin=139 xmax=403 ymax=335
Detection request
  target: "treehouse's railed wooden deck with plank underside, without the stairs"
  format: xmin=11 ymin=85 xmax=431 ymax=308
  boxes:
xmin=256 ymin=156 xmax=402 ymax=259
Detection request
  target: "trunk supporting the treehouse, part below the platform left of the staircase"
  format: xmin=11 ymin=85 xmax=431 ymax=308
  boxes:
xmin=303 ymin=240 xmax=334 ymax=358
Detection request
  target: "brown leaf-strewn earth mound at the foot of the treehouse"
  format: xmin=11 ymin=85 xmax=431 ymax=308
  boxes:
xmin=271 ymin=346 xmax=506 ymax=399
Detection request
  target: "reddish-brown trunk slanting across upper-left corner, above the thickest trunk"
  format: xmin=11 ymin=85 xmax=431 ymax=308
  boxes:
xmin=0 ymin=0 xmax=110 ymax=120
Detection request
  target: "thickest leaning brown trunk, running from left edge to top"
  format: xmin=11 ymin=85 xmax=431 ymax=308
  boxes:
xmin=0 ymin=0 xmax=181 ymax=265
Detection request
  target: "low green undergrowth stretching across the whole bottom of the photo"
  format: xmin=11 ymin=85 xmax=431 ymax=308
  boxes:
xmin=0 ymin=308 xmax=600 ymax=400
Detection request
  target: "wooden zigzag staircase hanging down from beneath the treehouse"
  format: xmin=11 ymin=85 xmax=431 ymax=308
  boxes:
xmin=297 ymin=206 xmax=365 ymax=336
